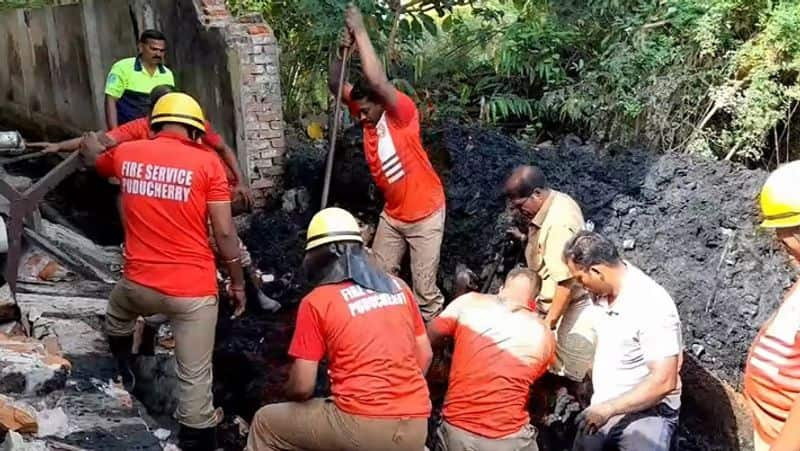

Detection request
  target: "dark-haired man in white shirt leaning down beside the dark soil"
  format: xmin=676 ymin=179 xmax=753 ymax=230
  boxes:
xmin=564 ymin=232 xmax=683 ymax=451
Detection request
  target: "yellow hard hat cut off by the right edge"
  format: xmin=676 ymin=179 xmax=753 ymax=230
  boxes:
xmin=759 ymin=161 xmax=800 ymax=229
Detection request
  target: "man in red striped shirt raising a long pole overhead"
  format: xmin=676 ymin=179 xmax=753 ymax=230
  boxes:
xmin=329 ymin=6 xmax=445 ymax=321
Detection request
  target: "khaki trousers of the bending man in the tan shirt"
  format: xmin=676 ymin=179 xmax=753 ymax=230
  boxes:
xmin=549 ymin=295 xmax=597 ymax=382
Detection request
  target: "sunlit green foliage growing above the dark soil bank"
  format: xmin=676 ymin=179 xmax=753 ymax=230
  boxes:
xmin=229 ymin=0 xmax=800 ymax=162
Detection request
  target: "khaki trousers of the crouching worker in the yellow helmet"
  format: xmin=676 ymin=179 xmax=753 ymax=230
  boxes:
xmin=245 ymin=398 xmax=428 ymax=451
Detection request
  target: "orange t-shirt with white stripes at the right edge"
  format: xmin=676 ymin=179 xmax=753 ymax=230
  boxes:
xmin=744 ymin=283 xmax=800 ymax=445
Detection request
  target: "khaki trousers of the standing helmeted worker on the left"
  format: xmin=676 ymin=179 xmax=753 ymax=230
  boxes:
xmin=106 ymin=279 xmax=218 ymax=429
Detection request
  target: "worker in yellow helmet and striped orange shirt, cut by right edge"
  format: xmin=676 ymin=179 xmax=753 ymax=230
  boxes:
xmin=744 ymin=161 xmax=800 ymax=451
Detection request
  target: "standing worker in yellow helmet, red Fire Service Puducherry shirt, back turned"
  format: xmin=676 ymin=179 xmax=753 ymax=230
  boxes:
xmin=82 ymin=93 xmax=245 ymax=451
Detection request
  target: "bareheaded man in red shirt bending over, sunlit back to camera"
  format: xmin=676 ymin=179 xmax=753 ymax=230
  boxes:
xmin=428 ymin=268 xmax=555 ymax=451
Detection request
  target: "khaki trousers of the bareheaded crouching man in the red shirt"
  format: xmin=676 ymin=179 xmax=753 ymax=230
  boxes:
xmin=436 ymin=420 xmax=539 ymax=451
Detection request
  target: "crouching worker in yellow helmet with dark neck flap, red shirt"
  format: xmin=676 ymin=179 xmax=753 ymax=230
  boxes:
xmin=246 ymin=208 xmax=432 ymax=451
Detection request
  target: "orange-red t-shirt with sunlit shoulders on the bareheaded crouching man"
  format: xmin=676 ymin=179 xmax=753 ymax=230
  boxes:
xmin=431 ymin=293 xmax=555 ymax=439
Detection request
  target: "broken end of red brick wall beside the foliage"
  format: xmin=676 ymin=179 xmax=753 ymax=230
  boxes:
xmin=195 ymin=0 xmax=286 ymax=206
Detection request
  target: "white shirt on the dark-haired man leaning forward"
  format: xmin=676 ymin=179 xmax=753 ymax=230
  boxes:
xmin=592 ymin=262 xmax=683 ymax=409
